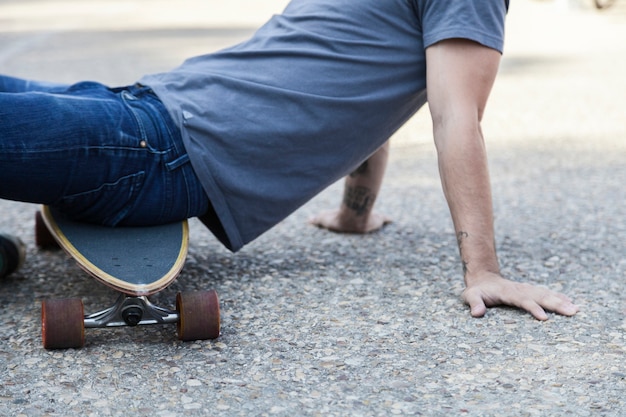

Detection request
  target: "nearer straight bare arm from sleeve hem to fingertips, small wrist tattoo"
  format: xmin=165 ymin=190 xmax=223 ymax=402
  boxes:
xmin=426 ymin=39 xmax=578 ymax=320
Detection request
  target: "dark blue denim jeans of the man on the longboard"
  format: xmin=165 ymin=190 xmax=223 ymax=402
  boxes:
xmin=0 ymin=76 xmax=209 ymax=226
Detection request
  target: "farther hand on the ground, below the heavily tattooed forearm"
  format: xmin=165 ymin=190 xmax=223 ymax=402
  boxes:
xmin=309 ymin=209 xmax=391 ymax=233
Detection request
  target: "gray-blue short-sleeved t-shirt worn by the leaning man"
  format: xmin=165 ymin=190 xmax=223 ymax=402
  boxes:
xmin=140 ymin=0 xmax=507 ymax=251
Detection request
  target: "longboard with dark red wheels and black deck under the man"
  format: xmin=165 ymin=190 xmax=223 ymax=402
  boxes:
xmin=35 ymin=206 xmax=220 ymax=349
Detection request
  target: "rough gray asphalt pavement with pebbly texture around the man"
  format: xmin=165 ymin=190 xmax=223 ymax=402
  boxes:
xmin=0 ymin=0 xmax=626 ymax=417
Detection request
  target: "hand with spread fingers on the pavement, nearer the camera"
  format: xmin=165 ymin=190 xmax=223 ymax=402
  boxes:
xmin=462 ymin=273 xmax=578 ymax=320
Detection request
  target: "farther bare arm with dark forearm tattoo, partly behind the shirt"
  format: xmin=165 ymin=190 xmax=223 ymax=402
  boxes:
xmin=310 ymin=142 xmax=391 ymax=233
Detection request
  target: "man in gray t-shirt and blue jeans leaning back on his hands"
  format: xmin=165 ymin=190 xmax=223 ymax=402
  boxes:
xmin=0 ymin=0 xmax=577 ymax=320
